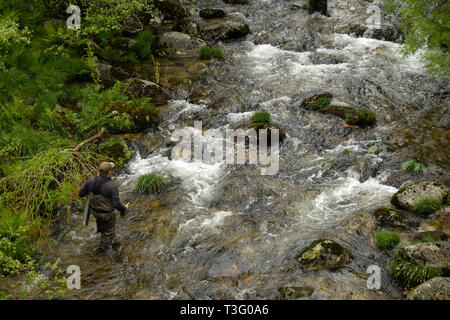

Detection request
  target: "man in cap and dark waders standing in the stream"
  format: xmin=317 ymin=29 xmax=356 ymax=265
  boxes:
xmin=79 ymin=162 xmax=130 ymax=255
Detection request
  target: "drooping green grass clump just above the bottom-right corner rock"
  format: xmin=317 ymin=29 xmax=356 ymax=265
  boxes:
xmin=391 ymin=260 xmax=442 ymax=288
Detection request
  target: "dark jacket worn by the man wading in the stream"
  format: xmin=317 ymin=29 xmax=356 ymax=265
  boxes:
xmin=78 ymin=176 xmax=125 ymax=215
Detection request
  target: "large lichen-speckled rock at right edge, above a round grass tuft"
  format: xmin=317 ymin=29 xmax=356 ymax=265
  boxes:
xmin=391 ymin=180 xmax=448 ymax=210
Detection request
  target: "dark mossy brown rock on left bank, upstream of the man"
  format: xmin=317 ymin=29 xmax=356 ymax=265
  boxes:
xmin=103 ymin=101 xmax=160 ymax=133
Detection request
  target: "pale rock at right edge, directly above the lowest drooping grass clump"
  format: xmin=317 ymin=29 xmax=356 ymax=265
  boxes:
xmin=397 ymin=241 xmax=450 ymax=273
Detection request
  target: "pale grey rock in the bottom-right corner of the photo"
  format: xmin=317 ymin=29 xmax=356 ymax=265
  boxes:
xmin=407 ymin=277 xmax=450 ymax=300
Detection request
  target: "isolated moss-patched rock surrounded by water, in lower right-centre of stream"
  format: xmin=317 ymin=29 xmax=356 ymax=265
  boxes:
xmin=298 ymin=239 xmax=352 ymax=271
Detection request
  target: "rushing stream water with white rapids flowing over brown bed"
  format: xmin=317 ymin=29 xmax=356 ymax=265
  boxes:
xmin=44 ymin=0 xmax=449 ymax=299
